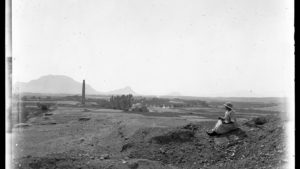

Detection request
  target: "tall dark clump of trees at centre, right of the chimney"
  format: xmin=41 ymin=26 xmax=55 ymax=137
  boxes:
xmin=109 ymin=94 xmax=133 ymax=111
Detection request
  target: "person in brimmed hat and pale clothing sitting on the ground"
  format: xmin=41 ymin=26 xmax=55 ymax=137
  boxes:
xmin=206 ymin=103 xmax=238 ymax=136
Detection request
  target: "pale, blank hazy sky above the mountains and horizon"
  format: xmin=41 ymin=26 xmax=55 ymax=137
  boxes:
xmin=12 ymin=0 xmax=294 ymax=96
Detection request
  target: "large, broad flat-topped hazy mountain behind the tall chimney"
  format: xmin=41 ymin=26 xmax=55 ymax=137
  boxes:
xmin=14 ymin=75 xmax=100 ymax=94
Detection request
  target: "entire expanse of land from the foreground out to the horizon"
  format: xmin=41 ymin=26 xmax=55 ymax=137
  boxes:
xmin=13 ymin=95 xmax=286 ymax=169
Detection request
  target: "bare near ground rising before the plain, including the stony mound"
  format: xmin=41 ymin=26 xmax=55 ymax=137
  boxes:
xmin=13 ymin=107 xmax=287 ymax=169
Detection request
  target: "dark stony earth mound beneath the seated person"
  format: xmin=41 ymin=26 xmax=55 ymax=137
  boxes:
xmin=122 ymin=116 xmax=285 ymax=168
